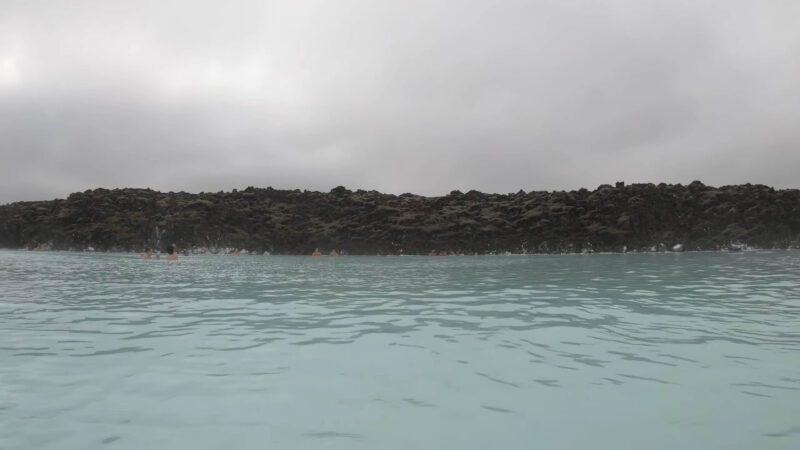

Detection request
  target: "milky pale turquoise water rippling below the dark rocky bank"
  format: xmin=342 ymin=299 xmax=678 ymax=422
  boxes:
xmin=0 ymin=251 xmax=800 ymax=450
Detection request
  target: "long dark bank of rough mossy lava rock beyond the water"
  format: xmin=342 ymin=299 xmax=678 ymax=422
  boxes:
xmin=0 ymin=181 xmax=800 ymax=255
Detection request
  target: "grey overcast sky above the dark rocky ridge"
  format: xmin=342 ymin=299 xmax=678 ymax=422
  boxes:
xmin=0 ymin=0 xmax=800 ymax=203
